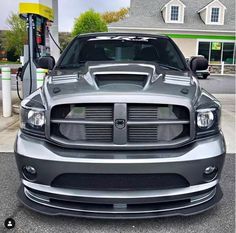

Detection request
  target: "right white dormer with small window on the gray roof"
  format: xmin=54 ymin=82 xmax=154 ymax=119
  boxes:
xmin=198 ymin=0 xmax=226 ymax=25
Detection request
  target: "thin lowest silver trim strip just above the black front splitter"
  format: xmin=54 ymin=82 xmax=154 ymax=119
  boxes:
xmin=24 ymin=188 xmax=216 ymax=214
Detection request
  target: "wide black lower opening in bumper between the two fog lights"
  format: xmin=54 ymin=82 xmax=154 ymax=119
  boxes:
xmin=51 ymin=173 xmax=189 ymax=191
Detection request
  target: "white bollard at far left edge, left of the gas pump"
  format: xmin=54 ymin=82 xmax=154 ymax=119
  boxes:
xmin=2 ymin=67 xmax=12 ymax=117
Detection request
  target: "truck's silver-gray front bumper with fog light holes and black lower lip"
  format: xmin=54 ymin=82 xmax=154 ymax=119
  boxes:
xmin=15 ymin=132 xmax=225 ymax=218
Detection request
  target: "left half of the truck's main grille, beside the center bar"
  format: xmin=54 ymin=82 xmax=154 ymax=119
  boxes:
xmin=51 ymin=104 xmax=113 ymax=142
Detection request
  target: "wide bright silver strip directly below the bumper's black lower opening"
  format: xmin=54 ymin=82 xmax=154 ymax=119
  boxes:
xmin=22 ymin=179 xmax=219 ymax=199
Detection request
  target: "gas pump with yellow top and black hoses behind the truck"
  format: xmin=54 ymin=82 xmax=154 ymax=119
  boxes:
xmin=18 ymin=0 xmax=53 ymax=98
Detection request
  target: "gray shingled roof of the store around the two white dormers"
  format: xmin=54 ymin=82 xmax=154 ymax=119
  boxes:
xmin=109 ymin=0 xmax=235 ymax=31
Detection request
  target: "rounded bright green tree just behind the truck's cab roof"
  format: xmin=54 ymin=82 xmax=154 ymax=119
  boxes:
xmin=72 ymin=9 xmax=107 ymax=36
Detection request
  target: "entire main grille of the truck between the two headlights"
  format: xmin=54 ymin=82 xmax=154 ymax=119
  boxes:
xmin=50 ymin=103 xmax=190 ymax=147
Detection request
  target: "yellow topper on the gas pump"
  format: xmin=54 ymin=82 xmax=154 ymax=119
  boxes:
xmin=19 ymin=0 xmax=54 ymax=21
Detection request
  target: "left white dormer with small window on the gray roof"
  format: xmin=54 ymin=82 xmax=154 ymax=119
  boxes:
xmin=161 ymin=0 xmax=185 ymax=23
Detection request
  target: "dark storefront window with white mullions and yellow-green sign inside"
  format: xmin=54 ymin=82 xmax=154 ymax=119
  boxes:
xmin=198 ymin=41 xmax=236 ymax=64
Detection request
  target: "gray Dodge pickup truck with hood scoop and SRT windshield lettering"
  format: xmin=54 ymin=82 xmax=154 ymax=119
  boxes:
xmin=15 ymin=33 xmax=226 ymax=219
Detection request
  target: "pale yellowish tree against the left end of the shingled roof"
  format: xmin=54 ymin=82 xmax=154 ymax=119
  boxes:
xmin=101 ymin=7 xmax=129 ymax=24
